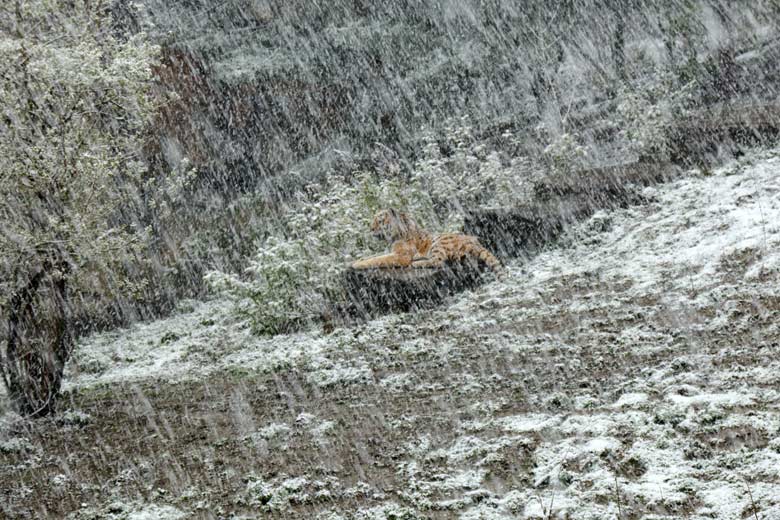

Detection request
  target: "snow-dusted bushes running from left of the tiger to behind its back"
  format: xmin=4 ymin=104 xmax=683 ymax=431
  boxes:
xmin=206 ymin=119 xmax=560 ymax=334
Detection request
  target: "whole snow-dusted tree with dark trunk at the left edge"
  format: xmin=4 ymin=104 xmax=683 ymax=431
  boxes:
xmin=0 ymin=0 xmax=157 ymax=416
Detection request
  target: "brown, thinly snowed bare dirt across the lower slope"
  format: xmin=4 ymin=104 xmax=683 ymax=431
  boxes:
xmin=0 ymin=287 xmax=780 ymax=519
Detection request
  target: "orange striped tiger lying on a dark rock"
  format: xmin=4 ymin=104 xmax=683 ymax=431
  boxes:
xmin=352 ymin=209 xmax=503 ymax=273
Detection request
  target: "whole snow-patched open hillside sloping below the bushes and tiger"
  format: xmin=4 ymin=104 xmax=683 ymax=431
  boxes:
xmin=0 ymin=149 xmax=780 ymax=520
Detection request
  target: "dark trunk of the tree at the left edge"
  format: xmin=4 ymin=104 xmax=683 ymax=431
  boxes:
xmin=0 ymin=262 xmax=73 ymax=417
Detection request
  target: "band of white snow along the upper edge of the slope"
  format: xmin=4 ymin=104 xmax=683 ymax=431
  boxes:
xmin=66 ymin=151 xmax=780 ymax=387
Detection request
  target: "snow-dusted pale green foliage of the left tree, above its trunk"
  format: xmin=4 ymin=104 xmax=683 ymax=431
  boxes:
xmin=0 ymin=0 xmax=157 ymax=305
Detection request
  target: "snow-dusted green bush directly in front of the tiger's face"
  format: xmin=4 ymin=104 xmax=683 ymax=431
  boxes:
xmin=206 ymin=173 xmax=440 ymax=334
